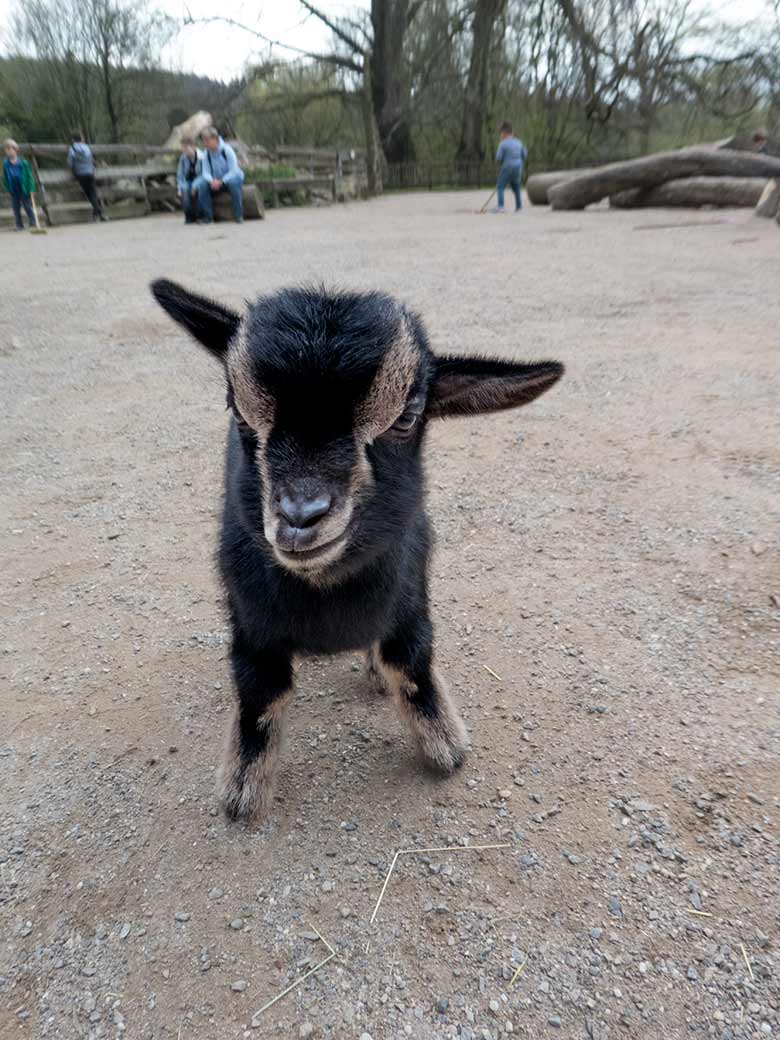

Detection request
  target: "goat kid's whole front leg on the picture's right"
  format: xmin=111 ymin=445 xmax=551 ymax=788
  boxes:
xmin=373 ymin=618 xmax=468 ymax=773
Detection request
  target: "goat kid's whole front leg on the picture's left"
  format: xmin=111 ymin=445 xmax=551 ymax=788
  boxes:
xmin=219 ymin=634 xmax=292 ymax=821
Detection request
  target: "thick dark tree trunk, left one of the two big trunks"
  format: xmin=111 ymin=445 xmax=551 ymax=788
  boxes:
xmin=371 ymin=0 xmax=415 ymax=162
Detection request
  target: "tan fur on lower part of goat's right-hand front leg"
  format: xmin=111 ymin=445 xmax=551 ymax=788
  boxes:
xmin=376 ymin=654 xmax=468 ymax=773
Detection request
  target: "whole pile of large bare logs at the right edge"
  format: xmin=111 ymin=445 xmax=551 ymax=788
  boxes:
xmin=526 ymin=138 xmax=780 ymax=224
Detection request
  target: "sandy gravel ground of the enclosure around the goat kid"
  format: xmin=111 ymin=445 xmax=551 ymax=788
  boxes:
xmin=0 ymin=193 xmax=780 ymax=1040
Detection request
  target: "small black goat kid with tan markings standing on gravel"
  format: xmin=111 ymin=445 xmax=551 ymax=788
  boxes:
xmin=152 ymin=280 xmax=564 ymax=818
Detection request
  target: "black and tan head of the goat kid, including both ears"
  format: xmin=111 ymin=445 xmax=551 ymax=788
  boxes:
xmin=152 ymin=280 xmax=564 ymax=580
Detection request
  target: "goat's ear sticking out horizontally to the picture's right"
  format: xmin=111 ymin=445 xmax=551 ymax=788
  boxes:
xmin=426 ymin=357 xmax=564 ymax=419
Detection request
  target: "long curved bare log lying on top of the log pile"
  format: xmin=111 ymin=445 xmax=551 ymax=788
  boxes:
xmin=547 ymin=148 xmax=780 ymax=209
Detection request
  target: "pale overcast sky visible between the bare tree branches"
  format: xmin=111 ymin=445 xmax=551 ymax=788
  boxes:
xmin=0 ymin=0 xmax=768 ymax=79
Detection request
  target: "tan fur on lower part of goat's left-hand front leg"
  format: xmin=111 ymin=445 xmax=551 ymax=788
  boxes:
xmin=217 ymin=693 xmax=291 ymax=823
